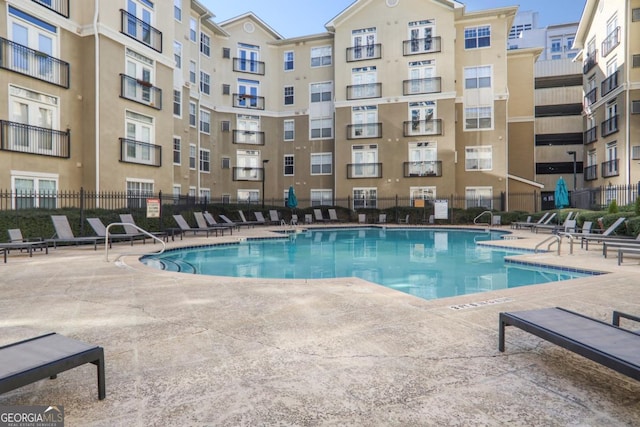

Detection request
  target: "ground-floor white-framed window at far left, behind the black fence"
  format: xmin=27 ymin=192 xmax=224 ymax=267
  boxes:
xmin=11 ymin=171 xmax=58 ymax=209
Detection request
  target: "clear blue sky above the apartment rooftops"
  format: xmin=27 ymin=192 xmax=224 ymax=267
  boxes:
xmin=200 ymin=0 xmax=586 ymax=38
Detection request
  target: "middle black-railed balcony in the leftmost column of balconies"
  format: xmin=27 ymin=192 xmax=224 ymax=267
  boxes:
xmin=0 ymin=37 xmax=69 ymax=89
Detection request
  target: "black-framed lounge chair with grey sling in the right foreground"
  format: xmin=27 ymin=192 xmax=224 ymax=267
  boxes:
xmin=498 ymin=307 xmax=640 ymax=380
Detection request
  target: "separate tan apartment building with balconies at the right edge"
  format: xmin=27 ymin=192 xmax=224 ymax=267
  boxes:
xmin=575 ymin=0 xmax=640 ymax=197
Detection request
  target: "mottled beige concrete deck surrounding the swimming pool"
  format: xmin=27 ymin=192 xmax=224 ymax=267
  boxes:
xmin=0 ymin=227 xmax=640 ymax=426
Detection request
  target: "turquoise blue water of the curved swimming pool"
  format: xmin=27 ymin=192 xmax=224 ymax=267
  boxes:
xmin=143 ymin=228 xmax=588 ymax=299
